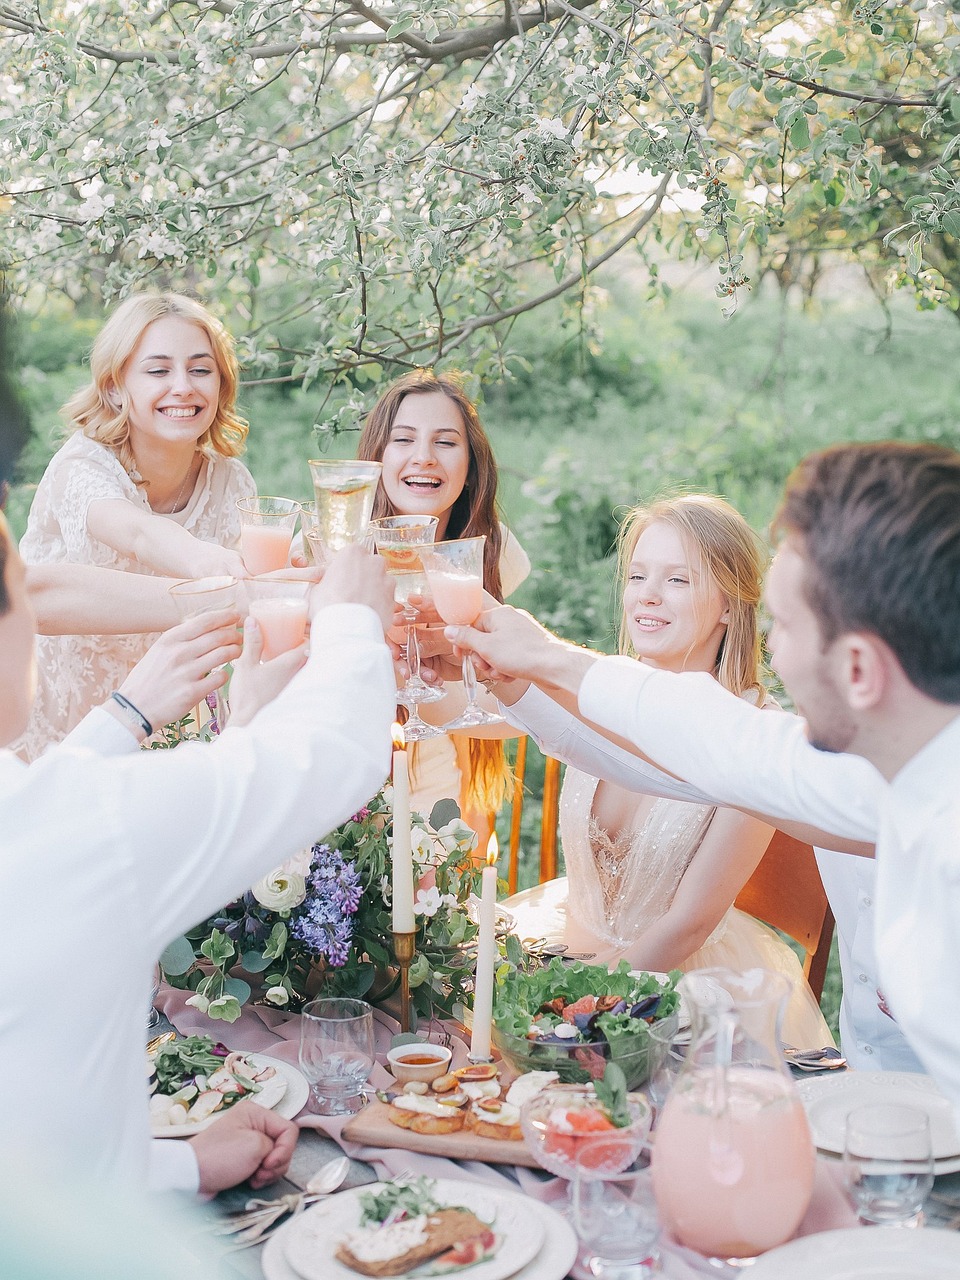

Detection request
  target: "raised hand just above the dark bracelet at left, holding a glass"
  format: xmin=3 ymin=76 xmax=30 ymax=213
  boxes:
xmin=112 ymin=609 xmax=241 ymax=728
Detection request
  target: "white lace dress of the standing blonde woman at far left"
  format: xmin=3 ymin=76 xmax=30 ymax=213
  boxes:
xmin=15 ymin=431 xmax=256 ymax=760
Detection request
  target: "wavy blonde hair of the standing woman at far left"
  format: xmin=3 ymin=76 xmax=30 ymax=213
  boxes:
xmin=60 ymin=293 xmax=250 ymax=484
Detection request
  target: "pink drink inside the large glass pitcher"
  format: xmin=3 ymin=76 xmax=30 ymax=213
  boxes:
xmin=653 ymin=1066 xmax=814 ymax=1258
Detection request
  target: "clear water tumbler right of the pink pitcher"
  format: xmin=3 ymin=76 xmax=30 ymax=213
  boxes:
xmin=844 ymin=1102 xmax=933 ymax=1226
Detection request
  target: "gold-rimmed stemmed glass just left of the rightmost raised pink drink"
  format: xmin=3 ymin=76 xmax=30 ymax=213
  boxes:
xmin=370 ymin=516 xmax=444 ymax=742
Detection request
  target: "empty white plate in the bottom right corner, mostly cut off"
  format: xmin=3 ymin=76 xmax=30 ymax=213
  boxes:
xmin=749 ymin=1226 xmax=960 ymax=1280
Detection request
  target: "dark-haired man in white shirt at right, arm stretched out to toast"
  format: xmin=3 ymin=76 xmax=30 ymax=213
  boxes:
xmin=447 ymin=444 xmax=960 ymax=1114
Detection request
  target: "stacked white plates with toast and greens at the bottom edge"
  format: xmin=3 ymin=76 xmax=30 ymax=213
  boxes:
xmin=262 ymin=1178 xmax=563 ymax=1280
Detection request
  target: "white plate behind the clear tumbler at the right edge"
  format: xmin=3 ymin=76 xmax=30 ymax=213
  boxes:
xmin=796 ymin=1071 xmax=960 ymax=1172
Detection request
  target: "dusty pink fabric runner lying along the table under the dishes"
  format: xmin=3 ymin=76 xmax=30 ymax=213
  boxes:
xmin=156 ymin=986 xmax=856 ymax=1280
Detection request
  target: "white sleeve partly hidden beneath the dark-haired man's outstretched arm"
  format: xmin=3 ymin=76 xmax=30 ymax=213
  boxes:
xmin=500 ymin=685 xmax=714 ymax=804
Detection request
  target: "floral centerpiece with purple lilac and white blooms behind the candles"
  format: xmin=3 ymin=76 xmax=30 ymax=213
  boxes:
xmin=160 ymin=786 xmax=491 ymax=1021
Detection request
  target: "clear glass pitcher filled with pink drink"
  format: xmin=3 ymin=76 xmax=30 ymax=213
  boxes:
xmin=653 ymin=969 xmax=815 ymax=1265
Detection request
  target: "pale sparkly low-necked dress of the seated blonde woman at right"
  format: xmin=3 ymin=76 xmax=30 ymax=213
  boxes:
xmin=504 ymin=767 xmax=833 ymax=1048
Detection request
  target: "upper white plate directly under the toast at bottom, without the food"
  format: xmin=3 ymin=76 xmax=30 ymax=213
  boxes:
xmin=284 ymin=1178 xmax=544 ymax=1280
